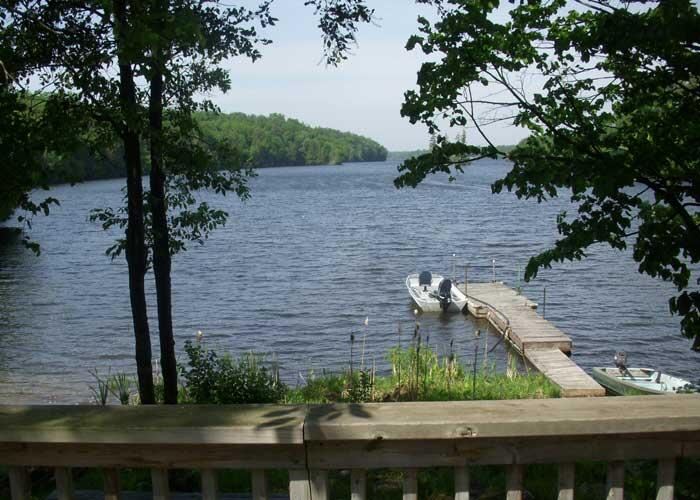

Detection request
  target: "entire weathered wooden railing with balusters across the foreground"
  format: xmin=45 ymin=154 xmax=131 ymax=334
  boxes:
xmin=0 ymin=395 xmax=700 ymax=500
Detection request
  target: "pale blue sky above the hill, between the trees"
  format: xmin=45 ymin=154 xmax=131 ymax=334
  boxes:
xmin=212 ymin=0 xmax=523 ymax=151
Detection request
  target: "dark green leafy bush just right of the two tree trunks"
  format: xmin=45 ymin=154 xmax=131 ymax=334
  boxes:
xmin=180 ymin=341 xmax=286 ymax=404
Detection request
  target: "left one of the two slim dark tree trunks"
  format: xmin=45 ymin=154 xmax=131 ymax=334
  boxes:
xmin=114 ymin=0 xmax=155 ymax=404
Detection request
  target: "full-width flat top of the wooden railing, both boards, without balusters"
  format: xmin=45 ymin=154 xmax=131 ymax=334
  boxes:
xmin=0 ymin=395 xmax=700 ymax=446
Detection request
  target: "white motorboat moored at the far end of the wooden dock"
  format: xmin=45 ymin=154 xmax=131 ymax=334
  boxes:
xmin=406 ymin=271 xmax=467 ymax=312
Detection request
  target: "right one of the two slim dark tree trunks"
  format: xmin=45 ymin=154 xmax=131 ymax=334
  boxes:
xmin=148 ymin=0 xmax=177 ymax=404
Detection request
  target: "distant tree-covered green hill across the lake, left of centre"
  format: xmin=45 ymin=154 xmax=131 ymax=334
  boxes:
xmin=50 ymin=113 xmax=387 ymax=184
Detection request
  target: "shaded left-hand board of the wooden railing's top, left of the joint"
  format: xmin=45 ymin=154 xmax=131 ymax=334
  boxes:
xmin=0 ymin=405 xmax=306 ymax=445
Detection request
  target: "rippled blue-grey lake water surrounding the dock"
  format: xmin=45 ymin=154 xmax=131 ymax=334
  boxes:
xmin=0 ymin=161 xmax=700 ymax=403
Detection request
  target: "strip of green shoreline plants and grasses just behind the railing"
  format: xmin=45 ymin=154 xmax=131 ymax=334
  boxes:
xmin=90 ymin=335 xmax=560 ymax=405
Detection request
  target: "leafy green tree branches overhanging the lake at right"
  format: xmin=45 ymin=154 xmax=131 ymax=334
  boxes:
xmin=395 ymin=0 xmax=700 ymax=350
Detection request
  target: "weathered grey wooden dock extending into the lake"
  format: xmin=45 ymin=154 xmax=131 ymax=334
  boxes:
xmin=459 ymin=282 xmax=605 ymax=397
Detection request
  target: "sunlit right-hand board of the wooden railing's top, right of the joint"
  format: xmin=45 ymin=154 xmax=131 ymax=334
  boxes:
xmin=304 ymin=395 xmax=700 ymax=441
